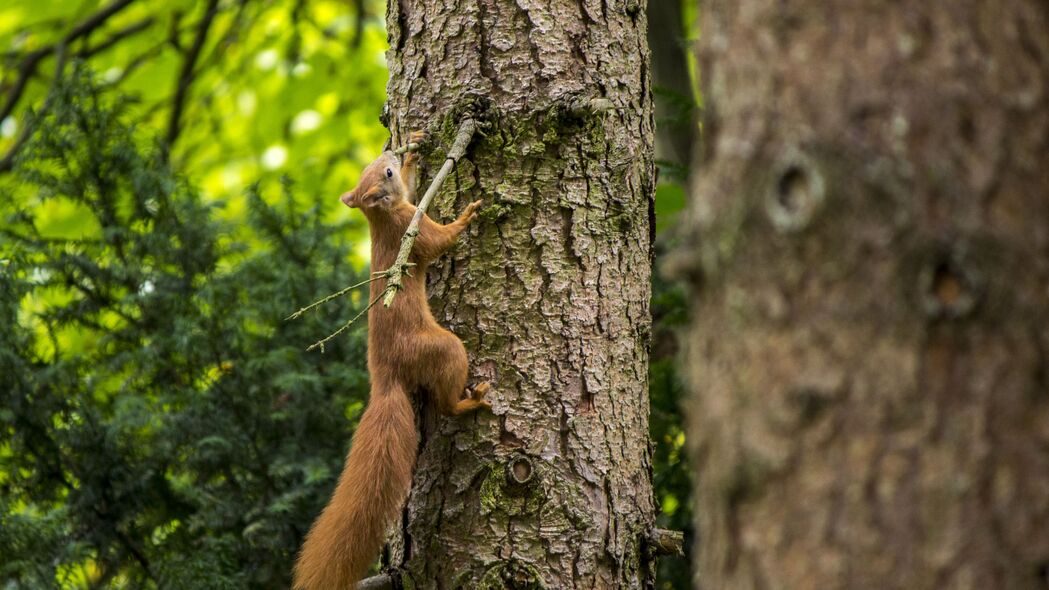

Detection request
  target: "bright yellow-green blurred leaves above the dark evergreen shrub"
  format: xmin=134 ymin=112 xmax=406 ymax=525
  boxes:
xmin=0 ymin=0 xmax=387 ymax=213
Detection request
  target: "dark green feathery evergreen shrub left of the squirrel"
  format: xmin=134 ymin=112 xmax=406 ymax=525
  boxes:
xmin=0 ymin=73 xmax=367 ymax=589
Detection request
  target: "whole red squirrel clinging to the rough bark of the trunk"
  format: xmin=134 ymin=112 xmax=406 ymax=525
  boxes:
xmin=294 ymin=132 xmax=491 ymax=590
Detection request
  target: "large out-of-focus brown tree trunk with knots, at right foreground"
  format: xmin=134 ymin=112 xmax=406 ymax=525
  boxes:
xmin=675 ymin=0 xmax=1049 ymax=589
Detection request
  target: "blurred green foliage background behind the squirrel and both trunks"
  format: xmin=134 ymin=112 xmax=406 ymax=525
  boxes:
xmin=0 ymin=0 xmax=702 ymax=588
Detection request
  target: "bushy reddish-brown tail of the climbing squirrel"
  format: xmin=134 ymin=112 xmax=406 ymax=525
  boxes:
xmin=294 ymin=385 xmax=418 ymax=590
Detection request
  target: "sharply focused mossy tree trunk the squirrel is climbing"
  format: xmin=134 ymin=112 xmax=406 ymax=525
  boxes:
xmin=387 ymin=0 xmax=655 ymax=588
